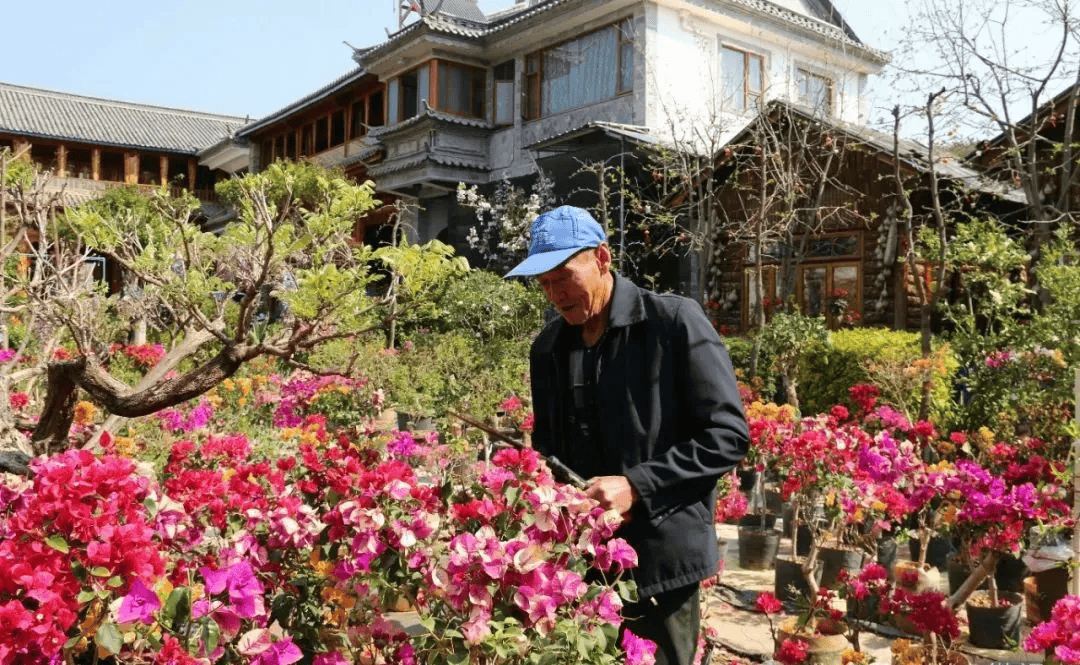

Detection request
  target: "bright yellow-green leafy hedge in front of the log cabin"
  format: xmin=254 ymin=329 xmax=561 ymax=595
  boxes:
xmin=799 ymin=328 xmax=959 ymax=426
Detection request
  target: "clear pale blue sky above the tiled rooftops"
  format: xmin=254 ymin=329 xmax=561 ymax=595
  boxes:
xmin=0 ymin=0 xmax=903 ymax=119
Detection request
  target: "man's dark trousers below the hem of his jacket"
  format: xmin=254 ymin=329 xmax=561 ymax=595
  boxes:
xmin=622 ymin=582 xmax=701 ymax=665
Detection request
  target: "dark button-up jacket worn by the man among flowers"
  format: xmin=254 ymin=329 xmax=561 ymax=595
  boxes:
xmin=529 ymin=273 xmax=748 ymax=598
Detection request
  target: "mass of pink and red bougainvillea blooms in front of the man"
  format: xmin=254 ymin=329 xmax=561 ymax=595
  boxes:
xmin=0 ymin=367 xmax=652 ymax=665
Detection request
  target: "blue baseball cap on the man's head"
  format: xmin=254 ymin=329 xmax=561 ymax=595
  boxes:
xmin=503 ymin=205 xmax=607 ymax=277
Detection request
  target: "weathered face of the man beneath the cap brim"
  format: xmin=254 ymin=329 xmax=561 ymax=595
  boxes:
xmin=537 ymin=245 xmax=611 ymax=326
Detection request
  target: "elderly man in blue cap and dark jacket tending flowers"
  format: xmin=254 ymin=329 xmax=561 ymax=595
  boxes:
xmin=507 ymin=206 xmax=748 ymax=665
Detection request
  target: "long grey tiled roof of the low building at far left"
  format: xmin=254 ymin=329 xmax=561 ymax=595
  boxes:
xmin=0 ymin=83 xmax=247 ymax=154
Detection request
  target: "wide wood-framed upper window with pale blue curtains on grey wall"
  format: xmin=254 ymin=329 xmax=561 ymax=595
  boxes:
xmin=523 ymin=19 xmax=634 ymax=120
